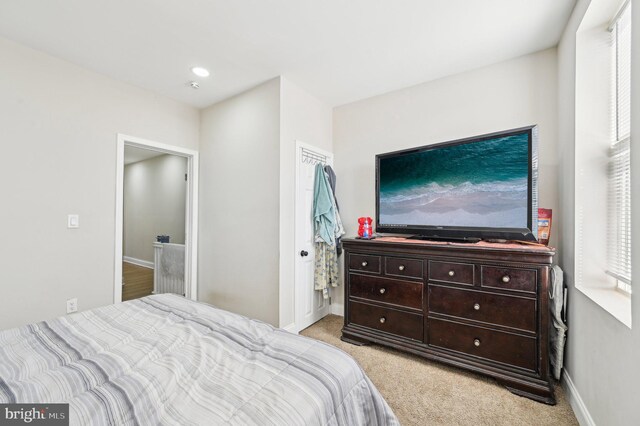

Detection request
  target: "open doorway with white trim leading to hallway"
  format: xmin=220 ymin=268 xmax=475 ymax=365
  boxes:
xmin=114 ymin=134 xmax=198 ymax=303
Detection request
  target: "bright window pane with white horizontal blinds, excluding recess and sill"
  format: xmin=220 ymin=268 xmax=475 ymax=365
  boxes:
xmin=607 ymin=2 xmax=631 ymax=294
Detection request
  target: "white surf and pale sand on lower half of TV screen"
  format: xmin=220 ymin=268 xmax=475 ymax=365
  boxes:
xmin=380 ymin=178 xmax=528 ymax=228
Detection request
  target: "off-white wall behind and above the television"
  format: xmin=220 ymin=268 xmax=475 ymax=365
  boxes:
xmin=333 ymin=49 xmax=561 ymax=310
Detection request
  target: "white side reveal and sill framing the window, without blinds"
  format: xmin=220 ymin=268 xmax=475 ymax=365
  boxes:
xmin=572 ymin=0 xmax=635 ymax=328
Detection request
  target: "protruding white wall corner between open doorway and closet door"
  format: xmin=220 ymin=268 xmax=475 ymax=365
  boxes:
xmin=199 ymin=77 xmax=332 ymax=327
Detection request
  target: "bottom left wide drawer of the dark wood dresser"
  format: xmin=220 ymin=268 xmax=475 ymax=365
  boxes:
xmin=349 ymin=301 xmax=424 ymax=340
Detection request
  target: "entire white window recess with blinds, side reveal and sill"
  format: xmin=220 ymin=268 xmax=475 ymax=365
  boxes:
xmin=573 ymin=0 xmax=638 ymax=328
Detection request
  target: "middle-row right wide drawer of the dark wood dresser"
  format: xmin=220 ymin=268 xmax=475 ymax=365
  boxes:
xmin=429 ymin=285 xmax=536 ymax=332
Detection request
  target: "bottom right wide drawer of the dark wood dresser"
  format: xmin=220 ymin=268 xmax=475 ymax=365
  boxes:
xmin=429 ymin=318 xmax=537 ymax=371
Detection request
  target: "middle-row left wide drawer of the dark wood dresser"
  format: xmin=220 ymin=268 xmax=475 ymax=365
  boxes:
xmin=349 ymin=274 xmax=423 ymax=310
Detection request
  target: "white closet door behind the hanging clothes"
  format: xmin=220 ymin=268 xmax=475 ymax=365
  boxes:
xmin=295 ymin=142 xmax=333 ymax=331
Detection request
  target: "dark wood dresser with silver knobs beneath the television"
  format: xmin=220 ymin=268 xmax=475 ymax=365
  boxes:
xmin=342 ymin=237 xmax=555 ymax=404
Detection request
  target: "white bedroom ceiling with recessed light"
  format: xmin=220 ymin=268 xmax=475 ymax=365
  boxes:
xmin=0 ymin=0 xmax=575 ymax=107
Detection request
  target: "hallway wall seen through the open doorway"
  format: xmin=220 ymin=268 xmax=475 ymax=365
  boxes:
xmin=123 ymin=155 xmax=188 ymax=263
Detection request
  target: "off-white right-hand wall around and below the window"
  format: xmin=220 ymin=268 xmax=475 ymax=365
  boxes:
xmin=558 ymin=0 xmax=640 ymax=425
